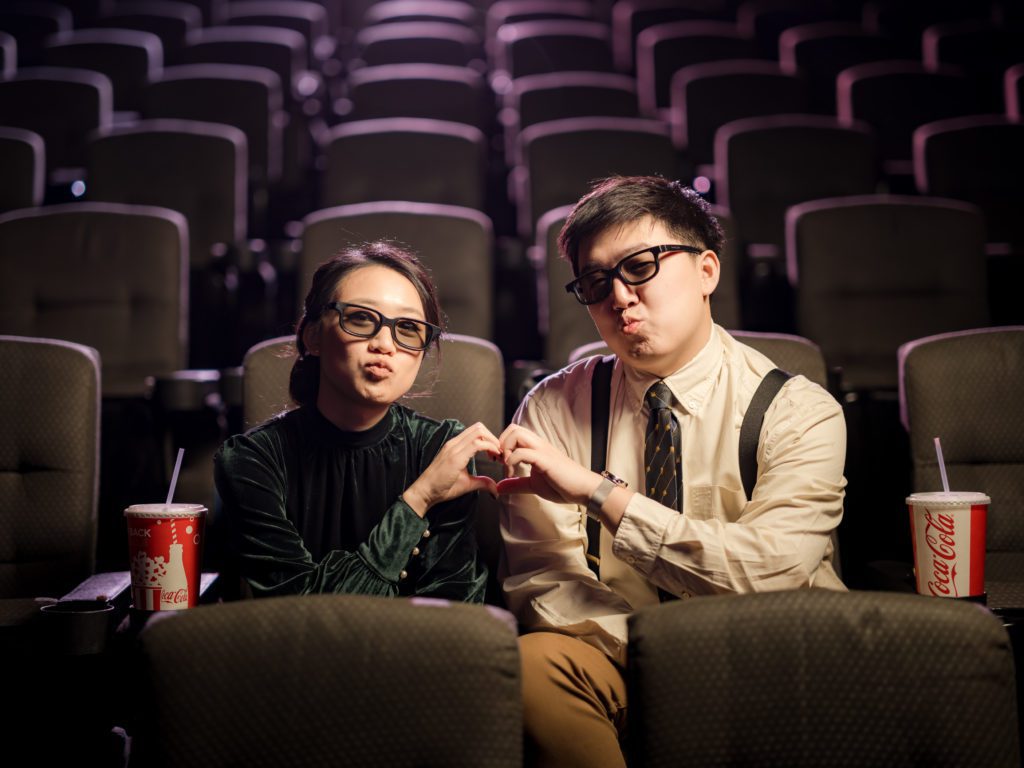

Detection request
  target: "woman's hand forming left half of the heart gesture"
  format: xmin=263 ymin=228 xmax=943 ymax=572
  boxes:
xmin=401 ymin=422 xmax=502 ymax=517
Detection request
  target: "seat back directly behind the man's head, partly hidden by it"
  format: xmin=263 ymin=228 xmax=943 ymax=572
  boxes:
xmin=534 ymin=206 xmax=741 ymax=369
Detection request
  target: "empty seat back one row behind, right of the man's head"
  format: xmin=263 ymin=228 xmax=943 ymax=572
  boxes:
xmin=786 ymin=196 xmax=988 ymax=391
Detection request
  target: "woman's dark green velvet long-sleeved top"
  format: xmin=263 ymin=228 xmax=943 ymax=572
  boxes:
xmin=214 ymin=404 xmax=487 ymax=602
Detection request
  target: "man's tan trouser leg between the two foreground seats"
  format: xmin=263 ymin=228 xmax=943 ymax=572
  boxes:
xmin=519 ymin=632 xmax=626 ymax=768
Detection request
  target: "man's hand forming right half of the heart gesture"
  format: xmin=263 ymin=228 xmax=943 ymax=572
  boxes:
xmin=498 ymin=424 xmax=601 ymax=505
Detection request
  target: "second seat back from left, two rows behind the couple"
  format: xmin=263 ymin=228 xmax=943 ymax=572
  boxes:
xmin=87 ymin=120 xmax=249 ymax=267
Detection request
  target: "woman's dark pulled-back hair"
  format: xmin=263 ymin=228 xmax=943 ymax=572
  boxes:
xmin=288 ymin=242 xmax=443 ymax=406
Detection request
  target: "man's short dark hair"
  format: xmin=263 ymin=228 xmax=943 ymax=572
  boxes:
xmin=558 ymin=176 xmax=725 ymax=275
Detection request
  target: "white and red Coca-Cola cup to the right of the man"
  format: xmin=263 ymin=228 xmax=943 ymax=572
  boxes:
xmin=906 ymin=492 xmax=991 ymax=599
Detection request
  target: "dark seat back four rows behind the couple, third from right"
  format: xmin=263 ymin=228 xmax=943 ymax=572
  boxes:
xmin=636 ymin=22 xmax=758 ymax=117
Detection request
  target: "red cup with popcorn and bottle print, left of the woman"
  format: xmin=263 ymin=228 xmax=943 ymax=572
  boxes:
xmin=125 ymin=504 xmax=206 ymax=610
